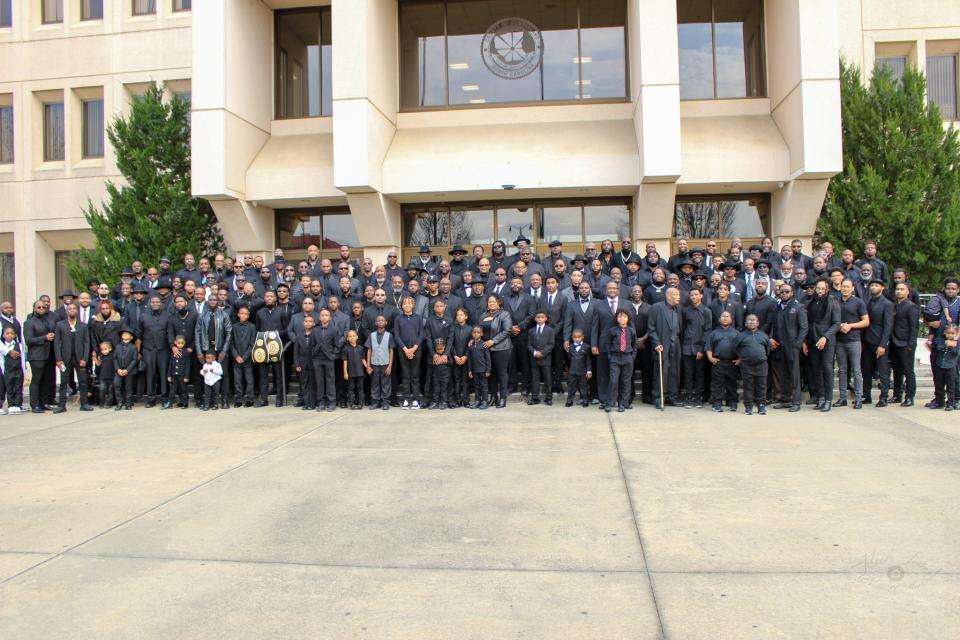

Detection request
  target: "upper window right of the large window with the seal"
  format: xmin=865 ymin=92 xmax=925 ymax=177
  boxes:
xmin=677 ymin=0 xmax=766 ymax=100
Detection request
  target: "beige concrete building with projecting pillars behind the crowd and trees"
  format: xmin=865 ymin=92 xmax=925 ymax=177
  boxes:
xmin=0 ymin=0 xmax=960 ymax=310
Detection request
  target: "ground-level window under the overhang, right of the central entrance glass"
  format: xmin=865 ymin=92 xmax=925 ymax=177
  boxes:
xmin=673 ymin=194 xmax=770 ymax=238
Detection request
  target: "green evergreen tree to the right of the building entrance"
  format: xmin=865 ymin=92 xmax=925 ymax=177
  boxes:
xmin=817 ymin=62 xmax=960 ymax=291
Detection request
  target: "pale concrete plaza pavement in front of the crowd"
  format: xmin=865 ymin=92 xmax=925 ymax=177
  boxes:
xmin=0 ymin=403 xmax=960 ymax=640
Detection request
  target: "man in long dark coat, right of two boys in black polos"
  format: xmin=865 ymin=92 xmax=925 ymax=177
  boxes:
xmin=770 ymin=284 xmax=809 ymax=411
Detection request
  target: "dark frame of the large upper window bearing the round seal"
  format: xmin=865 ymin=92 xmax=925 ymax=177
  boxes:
xmin=397 ymin=0 xmax=631 ymax=113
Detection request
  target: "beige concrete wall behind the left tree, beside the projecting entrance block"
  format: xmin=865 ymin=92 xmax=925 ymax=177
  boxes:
xmin=0 ymin=0 xmax=193 ymax=316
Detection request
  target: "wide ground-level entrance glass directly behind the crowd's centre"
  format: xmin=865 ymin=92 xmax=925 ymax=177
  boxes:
xmin=403 ymin=201 xmax=630 ymax=251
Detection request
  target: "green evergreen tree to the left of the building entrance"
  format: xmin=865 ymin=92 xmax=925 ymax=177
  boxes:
xmin=69 ymin=84 xmax=224 ymax=283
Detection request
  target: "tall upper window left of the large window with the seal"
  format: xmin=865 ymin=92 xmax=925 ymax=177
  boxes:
xmin=274 ymin=7 xmax=333 ymax=118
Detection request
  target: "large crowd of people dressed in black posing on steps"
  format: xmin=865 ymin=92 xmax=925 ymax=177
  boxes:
xmin=0 ymin=236 xmax=960 ymax=414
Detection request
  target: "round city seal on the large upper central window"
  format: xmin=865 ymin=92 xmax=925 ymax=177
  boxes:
xmin=480 ymin=18 xmax=543 ymax=80
